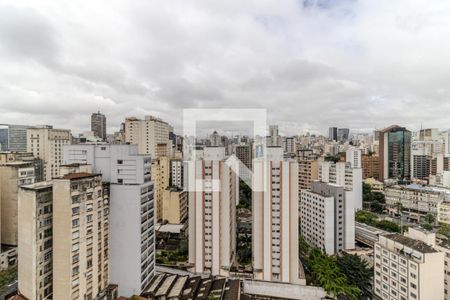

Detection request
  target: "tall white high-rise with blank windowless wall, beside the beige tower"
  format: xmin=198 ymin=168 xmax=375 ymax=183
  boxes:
xmin=64 ymin=144 xmax=155 ymax=296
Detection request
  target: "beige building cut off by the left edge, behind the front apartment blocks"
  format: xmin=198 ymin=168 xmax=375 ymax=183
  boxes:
xmin=0 ymin=161 xmax=35 ymax=246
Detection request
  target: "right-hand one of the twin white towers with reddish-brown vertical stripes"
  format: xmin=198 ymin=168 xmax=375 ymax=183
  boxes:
xmin=252 ymin=147 xmax=305 ymax=284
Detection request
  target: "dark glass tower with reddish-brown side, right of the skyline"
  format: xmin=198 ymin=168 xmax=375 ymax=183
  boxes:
xmin=378 ymin=125 xmax=411 ymax=181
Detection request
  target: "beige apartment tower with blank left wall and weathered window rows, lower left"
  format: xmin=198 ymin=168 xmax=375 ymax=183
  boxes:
xmin=53 ymin=173 xmax=109 ymax=300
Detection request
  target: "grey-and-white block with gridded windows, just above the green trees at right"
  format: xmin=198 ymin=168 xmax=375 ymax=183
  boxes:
xmin=300 ymin=181 xmax=355 ymax=255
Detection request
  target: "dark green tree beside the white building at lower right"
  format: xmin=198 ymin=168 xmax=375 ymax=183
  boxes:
xmin=337 ymin=254 xmax=373 ymax=296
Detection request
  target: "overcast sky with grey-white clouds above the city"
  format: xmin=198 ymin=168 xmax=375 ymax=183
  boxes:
xmin=0 ymin=0 xmax=450 ymax=134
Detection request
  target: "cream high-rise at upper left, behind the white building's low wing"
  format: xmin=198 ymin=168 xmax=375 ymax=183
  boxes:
xmin=27 ymin=126 xmax=71 ymax=180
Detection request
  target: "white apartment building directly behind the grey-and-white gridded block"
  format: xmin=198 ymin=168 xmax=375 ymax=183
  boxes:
xmin=319 ymin=161 xmax=362 ymax=210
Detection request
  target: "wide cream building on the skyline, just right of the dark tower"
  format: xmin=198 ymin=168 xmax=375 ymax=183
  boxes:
xmin=125 ymin=116 xmax=172 ymax=159
